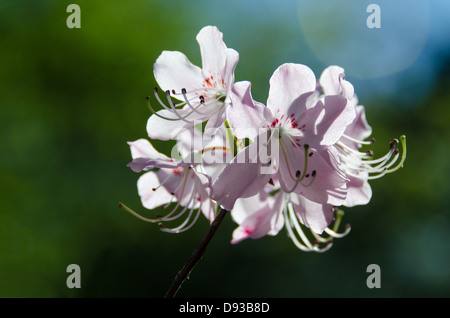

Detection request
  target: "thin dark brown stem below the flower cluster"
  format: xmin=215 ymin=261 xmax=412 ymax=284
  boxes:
xmin=164 ymin=209 xmax=228 ymax=298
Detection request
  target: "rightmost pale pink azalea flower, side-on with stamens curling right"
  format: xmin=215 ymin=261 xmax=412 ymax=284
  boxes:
xmin=319 ymin=66 xmax=406 ymax=207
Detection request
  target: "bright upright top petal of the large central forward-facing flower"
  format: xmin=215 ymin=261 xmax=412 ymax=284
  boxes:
xmin=267 ymin=63 xmax=316 ymax=114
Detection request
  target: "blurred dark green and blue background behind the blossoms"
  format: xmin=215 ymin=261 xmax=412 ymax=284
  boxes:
xmin=0 ymin=0 xmax=450 ymax=297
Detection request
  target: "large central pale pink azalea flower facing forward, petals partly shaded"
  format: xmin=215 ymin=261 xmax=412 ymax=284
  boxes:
xmin=213 ymin=64 xmax=355 ymax=210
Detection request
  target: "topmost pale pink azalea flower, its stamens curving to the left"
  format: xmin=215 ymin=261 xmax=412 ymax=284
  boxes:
xmin=147 ymin=26 xmax=239 ymax=140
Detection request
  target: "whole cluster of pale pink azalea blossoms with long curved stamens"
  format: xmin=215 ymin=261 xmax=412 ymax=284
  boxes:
xmin=125 ymin=26 xmax=406 ymax=252
